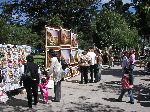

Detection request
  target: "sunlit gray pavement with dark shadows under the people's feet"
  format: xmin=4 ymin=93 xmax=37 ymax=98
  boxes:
xmin=0 ymin=65 xmax=150 ymax=112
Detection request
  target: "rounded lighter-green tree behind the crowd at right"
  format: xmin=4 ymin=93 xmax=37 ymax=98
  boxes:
xmin=94 ymin=9 xmax=138 ymax=48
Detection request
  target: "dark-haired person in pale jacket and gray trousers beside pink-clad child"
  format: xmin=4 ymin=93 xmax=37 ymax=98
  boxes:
xmin=48 ymin=49 xmax=64 ymax=102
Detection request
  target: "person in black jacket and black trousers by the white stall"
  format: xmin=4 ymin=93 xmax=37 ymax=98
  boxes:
xmin=20 ymin=55 xmax=40 ymax=108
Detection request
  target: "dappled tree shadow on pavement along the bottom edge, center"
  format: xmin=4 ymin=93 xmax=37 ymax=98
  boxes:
xmin=66 ymin=102 xmax=125 ymax=112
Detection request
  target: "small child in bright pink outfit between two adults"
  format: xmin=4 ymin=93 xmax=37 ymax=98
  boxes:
xmin=39 ymin=77 xmax=48 ymax=103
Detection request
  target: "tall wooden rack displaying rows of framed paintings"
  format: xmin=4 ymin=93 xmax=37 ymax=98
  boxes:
xmin=45 ymin=27 xmax=79 ymax=78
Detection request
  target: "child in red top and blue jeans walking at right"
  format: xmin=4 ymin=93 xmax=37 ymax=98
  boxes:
xmin=117 ymin=68 xmax=134 ymax=104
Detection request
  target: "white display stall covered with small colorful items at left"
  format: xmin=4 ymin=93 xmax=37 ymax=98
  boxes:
xmin=0 ymin=44 xmax=31 ymax=91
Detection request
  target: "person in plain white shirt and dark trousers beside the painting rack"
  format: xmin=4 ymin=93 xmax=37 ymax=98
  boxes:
xmin=87 ymin=48 xmax=96 ymax=83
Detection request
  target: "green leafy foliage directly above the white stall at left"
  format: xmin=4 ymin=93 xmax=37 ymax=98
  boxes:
xmin=0 ymin=17 xmax=40 ymax=47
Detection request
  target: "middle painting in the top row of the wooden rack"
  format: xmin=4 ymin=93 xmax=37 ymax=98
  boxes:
xmin=60 ymin=29 xmax=71 ymax=45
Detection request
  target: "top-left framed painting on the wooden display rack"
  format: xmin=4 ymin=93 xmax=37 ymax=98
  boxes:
xmin=46 ymin=27 xmax=60 ymax=46
